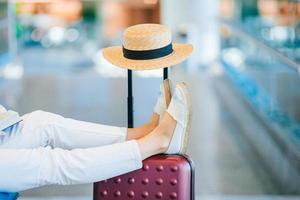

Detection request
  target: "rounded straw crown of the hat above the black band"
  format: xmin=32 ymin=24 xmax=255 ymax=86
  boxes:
xmin=123 ymin=24 xmax=172 ymax=51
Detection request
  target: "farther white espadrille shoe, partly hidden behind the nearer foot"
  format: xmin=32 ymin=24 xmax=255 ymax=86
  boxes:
xmin=154 ymin=79 xmax=171 ymax=119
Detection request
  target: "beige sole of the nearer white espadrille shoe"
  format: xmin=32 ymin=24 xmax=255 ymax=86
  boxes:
xmin=177 ymin=82 xmax=192 ymax=154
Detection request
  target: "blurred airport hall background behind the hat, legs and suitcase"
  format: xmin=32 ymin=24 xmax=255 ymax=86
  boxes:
xmin=0 ymin=0 xmax=300 ymax=200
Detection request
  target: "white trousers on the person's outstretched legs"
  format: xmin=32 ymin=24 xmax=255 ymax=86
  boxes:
xmin=0 ymin=111 xmax=142 ymax=192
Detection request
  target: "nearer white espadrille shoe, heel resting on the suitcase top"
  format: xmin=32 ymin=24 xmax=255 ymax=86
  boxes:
xmin=166 ymin=83 xmax=191 ymax=154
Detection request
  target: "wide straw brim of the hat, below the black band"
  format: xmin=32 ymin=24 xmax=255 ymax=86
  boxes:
xmin=102 ymin=43 xmax=193 ymax=70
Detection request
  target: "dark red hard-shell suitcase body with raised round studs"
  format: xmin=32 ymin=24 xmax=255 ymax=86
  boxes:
xmin=94 ymin=154 xmax=195 ymax=200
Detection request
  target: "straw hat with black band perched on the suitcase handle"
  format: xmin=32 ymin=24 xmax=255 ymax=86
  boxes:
xmin=103 ymin=24 xmax=193 ymax=70
